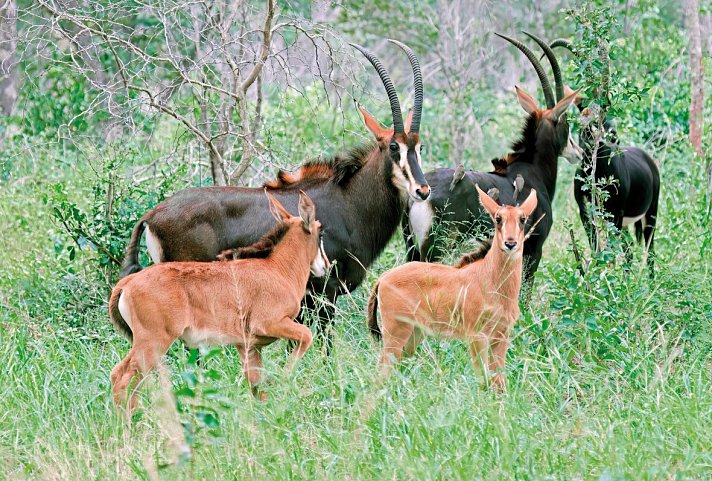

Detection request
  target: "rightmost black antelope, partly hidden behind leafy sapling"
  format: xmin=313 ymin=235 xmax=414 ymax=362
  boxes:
xmin=551 ymin=39 xmax=660 ymax=277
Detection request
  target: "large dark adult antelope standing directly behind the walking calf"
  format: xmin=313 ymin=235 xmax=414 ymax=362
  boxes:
xmin=121 ymin=40 xmax=430 ymax=346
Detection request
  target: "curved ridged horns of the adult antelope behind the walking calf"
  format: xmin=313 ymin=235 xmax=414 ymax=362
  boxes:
xmin=349 ymin=38 xmax=423 ymax=134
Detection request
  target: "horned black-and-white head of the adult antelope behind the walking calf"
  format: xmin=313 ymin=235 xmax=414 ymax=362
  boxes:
xmin=351 ymin=39 xmax=430 ymax=202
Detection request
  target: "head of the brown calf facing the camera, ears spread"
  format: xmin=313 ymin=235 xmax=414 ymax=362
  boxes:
xmin=475 ymin=185 xmax=537 ymax=256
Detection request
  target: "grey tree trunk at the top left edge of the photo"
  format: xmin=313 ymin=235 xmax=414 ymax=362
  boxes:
xmin=0 ymin=0 xmax=17 ymax=115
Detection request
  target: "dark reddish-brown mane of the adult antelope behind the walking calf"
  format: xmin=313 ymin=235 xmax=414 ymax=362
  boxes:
xmin=264 ymin=144 xmax=374 ymax=190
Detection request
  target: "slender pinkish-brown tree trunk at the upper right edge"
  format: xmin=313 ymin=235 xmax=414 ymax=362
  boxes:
xmin=685 ymin=0 xmax=709 ymax=158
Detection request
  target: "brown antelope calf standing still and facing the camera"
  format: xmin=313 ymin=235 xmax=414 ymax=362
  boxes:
xmin=368 ymin=186 xmax=537 ymax=389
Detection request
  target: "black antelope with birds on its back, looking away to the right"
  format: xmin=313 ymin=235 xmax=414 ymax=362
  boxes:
xmin=403 ymin=34 xmax=580 ymax=288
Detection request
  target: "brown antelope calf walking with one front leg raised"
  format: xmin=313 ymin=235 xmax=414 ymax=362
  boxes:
xmin=109 ymin=192 xmax=329 ymax=411
